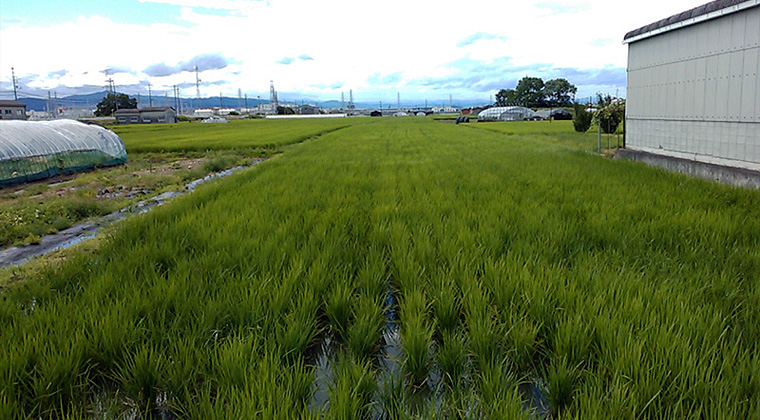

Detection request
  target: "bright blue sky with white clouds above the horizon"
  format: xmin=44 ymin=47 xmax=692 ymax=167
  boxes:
xmin=0 ymin=0 xmax=706 ymax=103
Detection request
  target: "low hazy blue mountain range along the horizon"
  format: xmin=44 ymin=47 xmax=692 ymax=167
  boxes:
xmin=18 ymin=91 xmax=492 ymax=111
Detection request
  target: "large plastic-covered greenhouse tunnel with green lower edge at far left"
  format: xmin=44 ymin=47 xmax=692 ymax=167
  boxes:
xmin=0 ymin=120 xmax=127 ymax=187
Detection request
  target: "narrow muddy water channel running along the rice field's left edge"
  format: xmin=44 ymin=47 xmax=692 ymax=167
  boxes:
xmin=0 ymin=159 xmax=265 ymax=268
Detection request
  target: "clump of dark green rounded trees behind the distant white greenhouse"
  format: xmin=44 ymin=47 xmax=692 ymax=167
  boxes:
xmin=495 ymin=77 xmax=578 ymax=108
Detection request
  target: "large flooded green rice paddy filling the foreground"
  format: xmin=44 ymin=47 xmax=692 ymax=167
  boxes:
xmin=0 ymin=118 xmax=760 ymax=419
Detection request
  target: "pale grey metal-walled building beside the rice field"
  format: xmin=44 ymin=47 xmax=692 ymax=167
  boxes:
xmin=624 ymin=0 xmax=760 ymax=177
